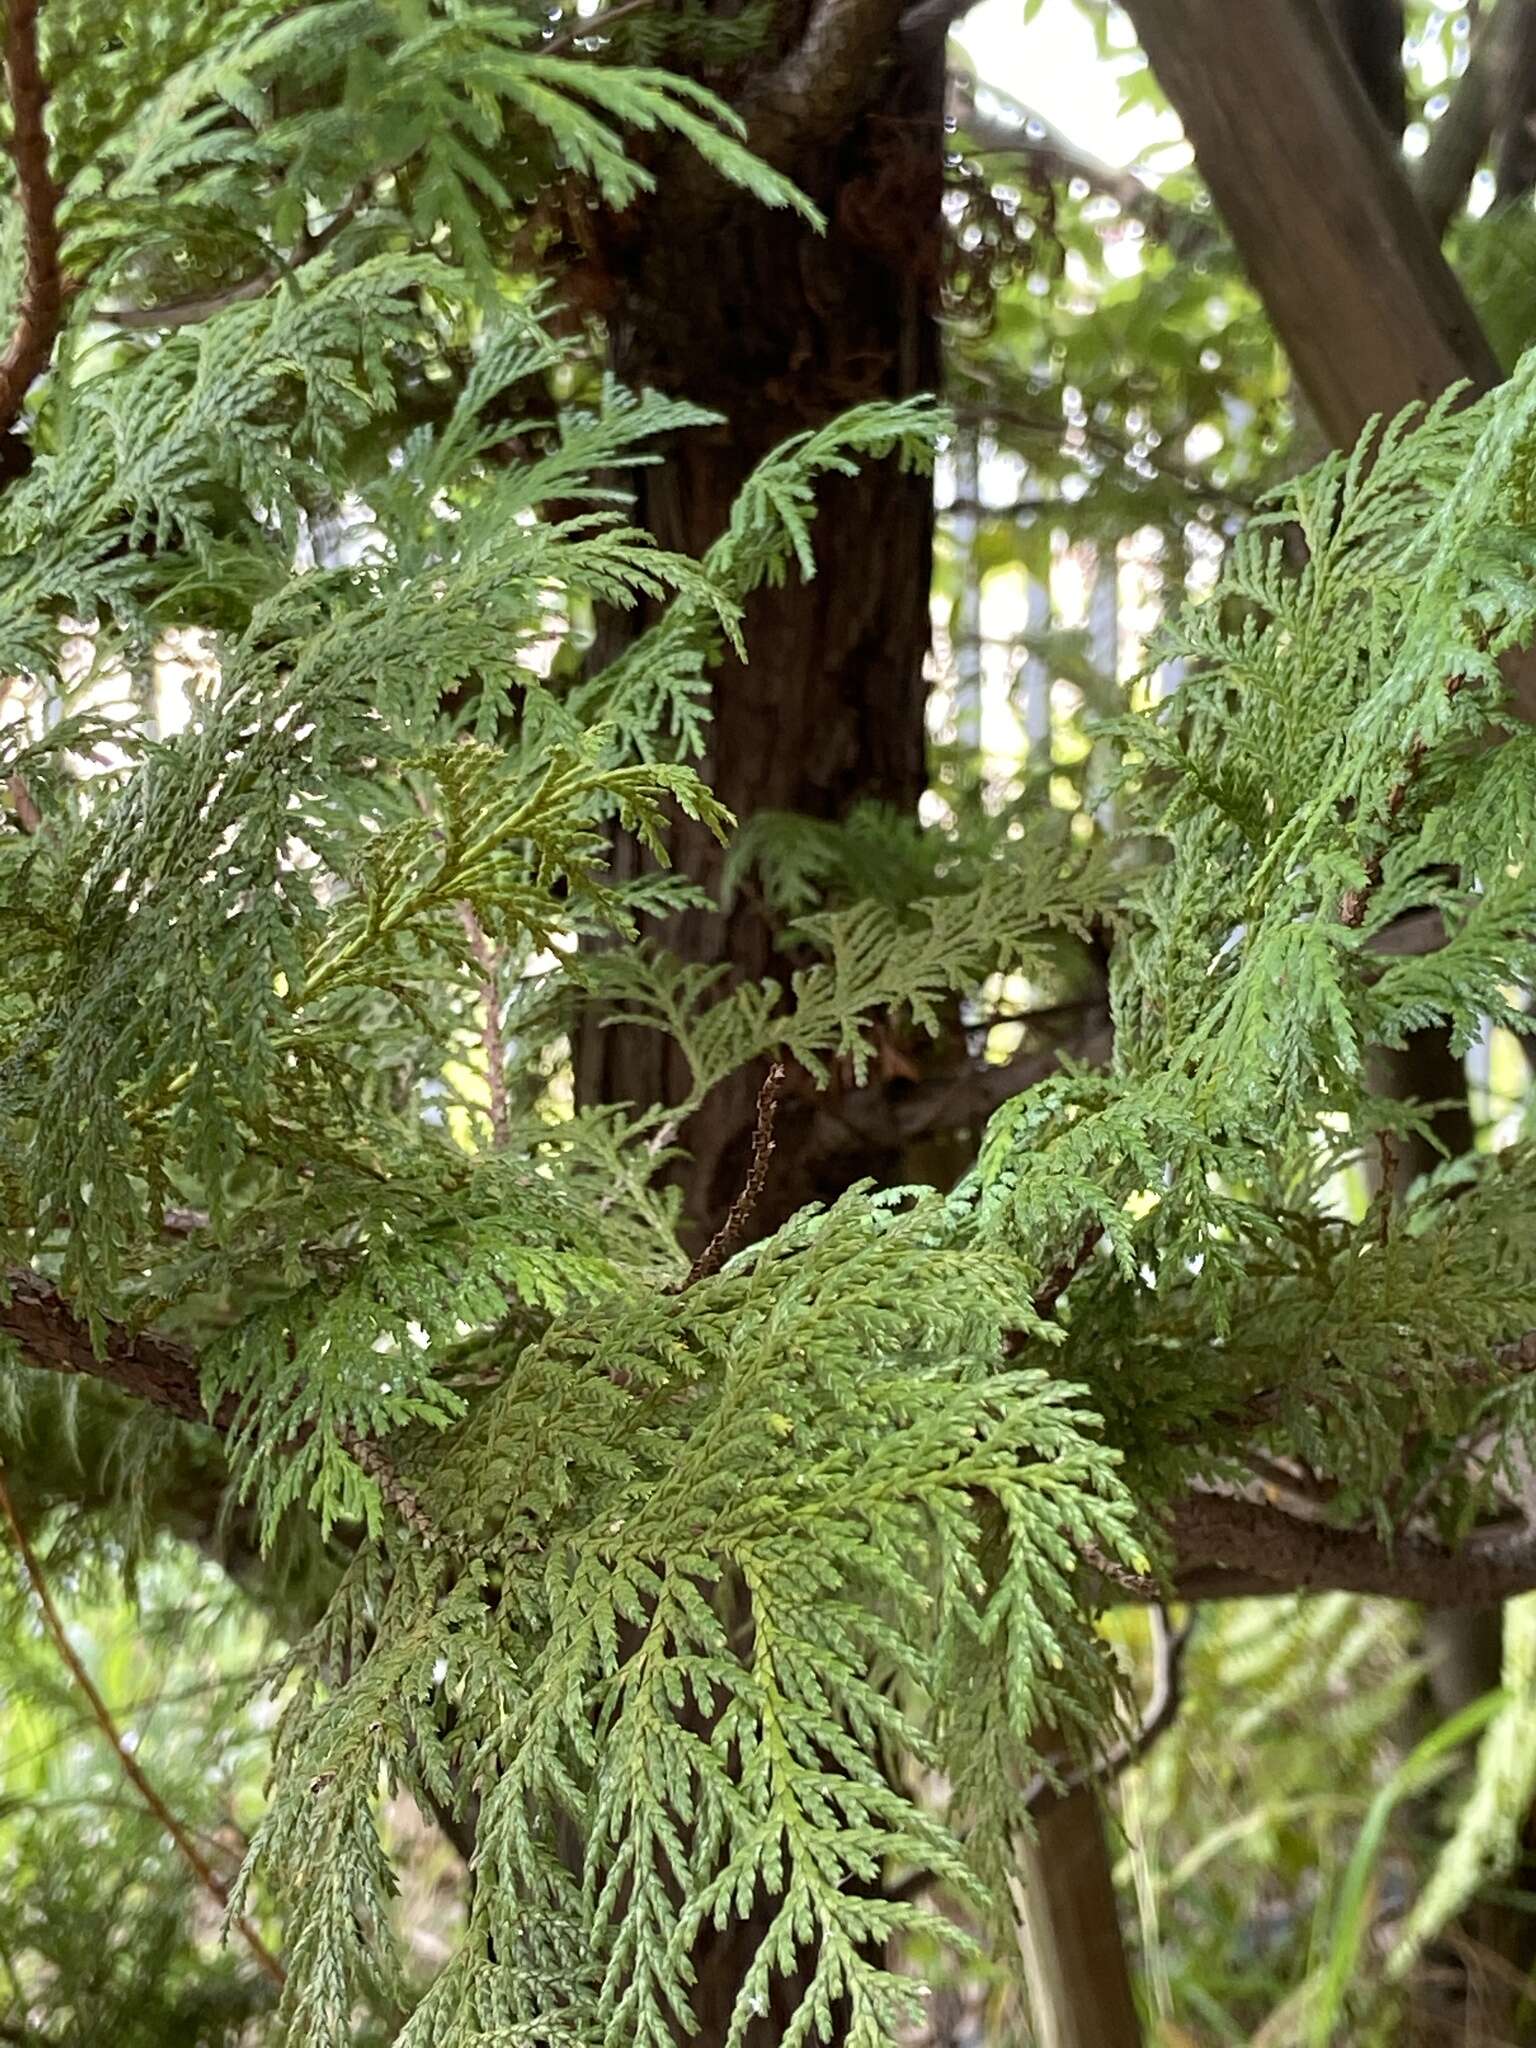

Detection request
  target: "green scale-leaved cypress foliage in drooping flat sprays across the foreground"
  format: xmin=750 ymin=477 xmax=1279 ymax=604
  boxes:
xmin=12 ymin=0 xmax=1536 ymax=2048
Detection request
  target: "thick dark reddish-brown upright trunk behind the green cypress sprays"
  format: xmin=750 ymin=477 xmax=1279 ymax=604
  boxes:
xmin=575 ymin=20 xmax=1139 ymax=2048
